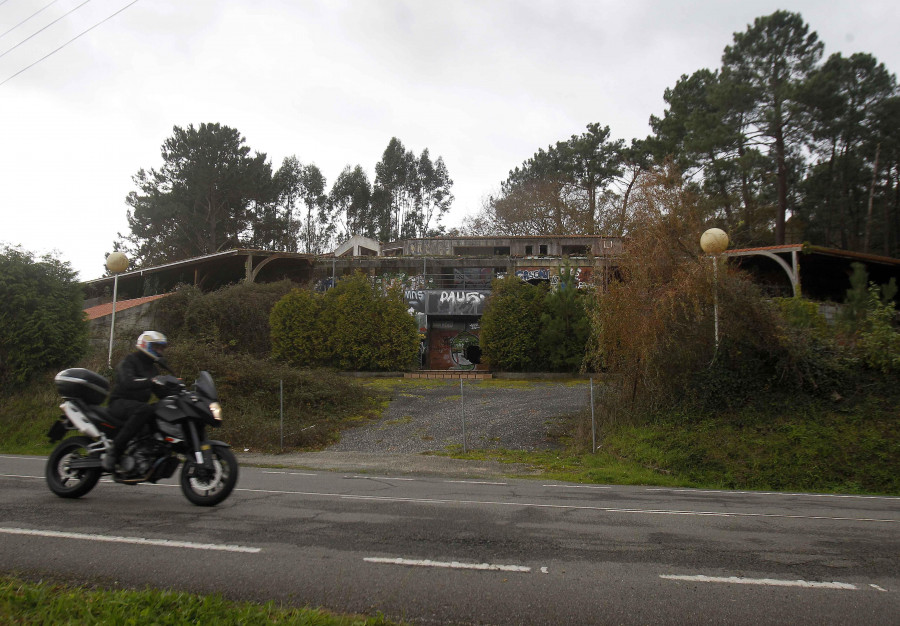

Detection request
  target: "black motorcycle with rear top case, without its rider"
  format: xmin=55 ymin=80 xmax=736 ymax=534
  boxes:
xmin=45 ymin=364 xmax=238 ymax=506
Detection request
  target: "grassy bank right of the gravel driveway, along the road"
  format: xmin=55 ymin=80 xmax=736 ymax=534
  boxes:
xmin=448 ymin=390 xmax=900 ymax=496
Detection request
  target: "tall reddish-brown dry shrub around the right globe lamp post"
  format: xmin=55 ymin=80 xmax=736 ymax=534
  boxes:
xmin=589 ymin=163 xmax=785 ymax=420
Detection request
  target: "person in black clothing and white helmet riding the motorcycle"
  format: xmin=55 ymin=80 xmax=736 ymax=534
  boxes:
xmin=101 ymin=330 xmax=168 ymax=472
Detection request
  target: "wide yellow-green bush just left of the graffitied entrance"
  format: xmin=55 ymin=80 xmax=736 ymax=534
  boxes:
xmin=270 ymin=272 xmax=419 ymax=371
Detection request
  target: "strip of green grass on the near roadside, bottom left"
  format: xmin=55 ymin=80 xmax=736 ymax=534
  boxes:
xmin=0 ymin=575 xmax=394 ymax=626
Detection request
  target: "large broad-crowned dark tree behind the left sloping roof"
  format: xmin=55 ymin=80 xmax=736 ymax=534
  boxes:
xmin=120 ymin=124 xmax=272 ymax=266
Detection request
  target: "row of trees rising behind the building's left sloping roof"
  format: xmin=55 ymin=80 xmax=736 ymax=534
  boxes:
xmin=114 ymin=123 xmax=453 ymax=266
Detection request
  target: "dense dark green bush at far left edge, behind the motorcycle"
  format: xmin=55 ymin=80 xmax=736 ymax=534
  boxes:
xmin=0 ymin=247 xmax=88 ymax=387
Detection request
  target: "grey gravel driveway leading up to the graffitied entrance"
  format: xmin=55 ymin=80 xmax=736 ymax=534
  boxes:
xmin=327 ymin=380 xmax=590 ymax=454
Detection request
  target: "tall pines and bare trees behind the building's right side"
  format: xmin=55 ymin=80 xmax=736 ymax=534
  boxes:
xmin=463 ymin=11 xmax=900 ymax=256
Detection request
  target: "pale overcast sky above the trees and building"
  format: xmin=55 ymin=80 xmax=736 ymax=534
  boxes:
xmin=0 ymin=0 xmax=900 ymax=280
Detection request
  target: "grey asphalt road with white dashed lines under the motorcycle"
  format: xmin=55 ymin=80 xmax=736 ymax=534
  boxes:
xmin=0 ymin=456 xmax=900 ymax=624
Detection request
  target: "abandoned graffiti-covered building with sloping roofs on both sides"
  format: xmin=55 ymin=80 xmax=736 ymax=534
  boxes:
xmin=84 ymin=236 xmax=900 ymax=370
